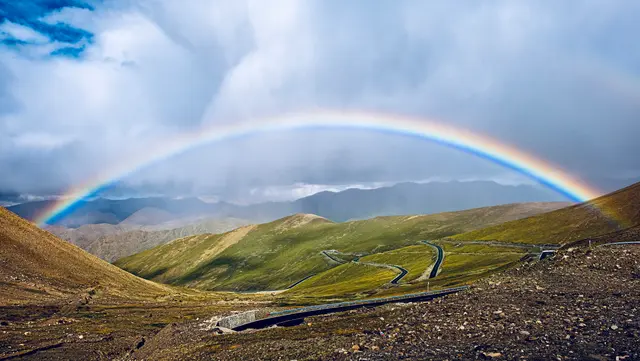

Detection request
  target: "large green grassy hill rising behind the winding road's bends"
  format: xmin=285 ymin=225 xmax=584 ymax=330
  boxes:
xmin=115 ymin=203 xmax=560 ymax=290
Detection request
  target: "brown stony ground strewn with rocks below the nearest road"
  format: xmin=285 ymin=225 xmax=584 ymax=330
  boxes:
xmin=130 ymin=245 xmax=640 ymax=361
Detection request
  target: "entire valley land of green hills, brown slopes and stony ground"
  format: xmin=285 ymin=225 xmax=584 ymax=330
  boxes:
xmin=0 ymin=186 xmax=640 ymax=360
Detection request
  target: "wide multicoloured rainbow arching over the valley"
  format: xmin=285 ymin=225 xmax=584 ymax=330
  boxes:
xmin=36 ymin=111 xmax=601 ymax=225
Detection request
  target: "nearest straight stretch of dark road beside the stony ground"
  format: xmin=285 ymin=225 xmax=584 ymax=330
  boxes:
xmin=233 ymin=286 xmax=469 ymax=331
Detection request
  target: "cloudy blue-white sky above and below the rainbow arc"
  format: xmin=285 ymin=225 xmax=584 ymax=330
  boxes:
xmin=0 ymin=0 xmax=640 ymax=202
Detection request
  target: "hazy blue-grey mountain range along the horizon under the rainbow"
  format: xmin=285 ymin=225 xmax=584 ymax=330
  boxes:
xmin=8 ymin=181 xmax=563 ymax=227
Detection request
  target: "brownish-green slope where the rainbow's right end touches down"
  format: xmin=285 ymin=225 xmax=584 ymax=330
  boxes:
xmin=453 ymin=183 xmax=640 ymax=244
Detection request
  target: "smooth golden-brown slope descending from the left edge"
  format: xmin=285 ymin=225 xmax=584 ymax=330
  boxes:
xmin=0 ymin=207 xmax=169 ymax=305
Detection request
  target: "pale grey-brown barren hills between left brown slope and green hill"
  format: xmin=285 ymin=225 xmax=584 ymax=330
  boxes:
xmin=47 ymin=215 xmax=250 ymax=262
